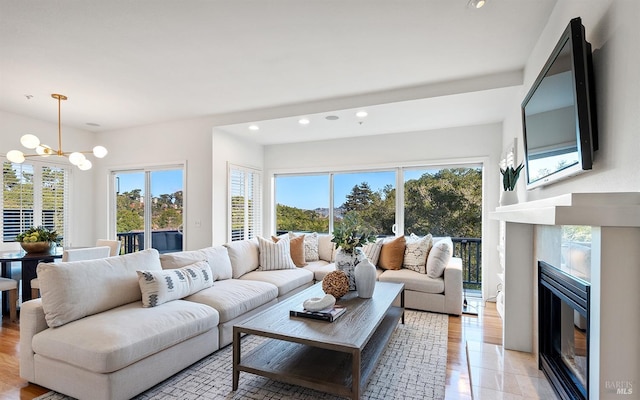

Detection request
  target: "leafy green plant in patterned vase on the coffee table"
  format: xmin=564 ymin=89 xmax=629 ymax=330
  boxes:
xmin=331 ymin=211 xmax=376 ymax=290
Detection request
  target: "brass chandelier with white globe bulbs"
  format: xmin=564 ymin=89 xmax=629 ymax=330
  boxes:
xmin=7 ymin=93 xmax=107 ymax=171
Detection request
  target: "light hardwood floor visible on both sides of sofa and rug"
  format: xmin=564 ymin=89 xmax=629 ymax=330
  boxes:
xmin=0 ymin=302 xmax=502 ymax=400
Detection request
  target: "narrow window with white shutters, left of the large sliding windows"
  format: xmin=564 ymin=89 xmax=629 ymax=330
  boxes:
xmin=227 ymin=164 xmax=262 ymax=241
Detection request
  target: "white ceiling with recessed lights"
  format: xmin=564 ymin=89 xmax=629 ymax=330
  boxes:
xmin=0 ymin=0 xmax=556 ymax=143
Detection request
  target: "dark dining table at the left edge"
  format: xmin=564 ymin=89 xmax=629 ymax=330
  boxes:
xmin=0 ymin=247 xmax=63 ymax=314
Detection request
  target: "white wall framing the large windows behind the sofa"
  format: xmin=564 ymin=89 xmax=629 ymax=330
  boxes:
xmin=264 ymin=124 xmax=502 ymax=298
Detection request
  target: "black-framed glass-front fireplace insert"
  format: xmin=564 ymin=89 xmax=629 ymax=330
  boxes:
xmin=538 ymin=261 xmax=591 ymax=399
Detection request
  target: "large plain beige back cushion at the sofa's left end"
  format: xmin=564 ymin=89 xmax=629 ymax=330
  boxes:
xmin=37 ymin=249 xmax=162 ymax=328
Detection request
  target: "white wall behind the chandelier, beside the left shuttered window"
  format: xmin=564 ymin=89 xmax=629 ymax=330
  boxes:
xmin=0 ymin=111 xmax=96 ymax=246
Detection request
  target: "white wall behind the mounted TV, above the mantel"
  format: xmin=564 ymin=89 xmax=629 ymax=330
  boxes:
xmin=503 ymin=0 xmax=640 ymax=200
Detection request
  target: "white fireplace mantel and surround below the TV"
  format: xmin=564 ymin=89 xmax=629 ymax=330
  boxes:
xmin=489 ymin=192 xmax=640 ymax=400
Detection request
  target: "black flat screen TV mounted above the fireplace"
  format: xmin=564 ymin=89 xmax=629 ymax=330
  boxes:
xmin=522 ymin=18 xmax=598 ymax=189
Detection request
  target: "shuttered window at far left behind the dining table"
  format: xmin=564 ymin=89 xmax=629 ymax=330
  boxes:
xmin=2 ymin=161 xmax=71 ymax=245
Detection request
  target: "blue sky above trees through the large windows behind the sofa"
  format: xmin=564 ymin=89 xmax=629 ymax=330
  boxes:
xmin=276 ymin=169 xmax=435 ymax=210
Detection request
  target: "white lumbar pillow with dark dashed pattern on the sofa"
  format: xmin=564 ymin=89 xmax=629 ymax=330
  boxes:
xmin=136 ymin=261 xmax=213 ymax=307
